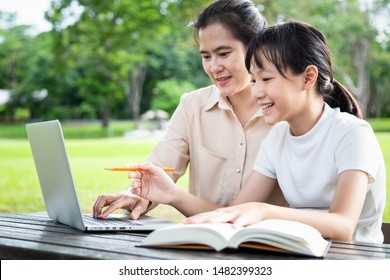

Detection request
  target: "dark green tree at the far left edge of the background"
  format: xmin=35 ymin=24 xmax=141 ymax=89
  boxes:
xmin=0 ymin=13 xmax=54 ymax=121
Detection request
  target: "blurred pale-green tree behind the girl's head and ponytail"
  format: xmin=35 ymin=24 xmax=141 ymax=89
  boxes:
xmin=254 ymin=0 xmax=389 ymax=117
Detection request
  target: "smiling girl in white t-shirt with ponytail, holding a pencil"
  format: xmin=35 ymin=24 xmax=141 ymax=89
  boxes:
xmin=127 ymin=22 xmax=386 ymax=243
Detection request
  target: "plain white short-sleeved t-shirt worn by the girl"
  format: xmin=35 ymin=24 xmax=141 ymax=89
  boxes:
xmin=254 ymin=104 xmax=386 ymax=243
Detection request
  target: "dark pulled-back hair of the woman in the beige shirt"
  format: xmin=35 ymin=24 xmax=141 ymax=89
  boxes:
xmin=190 ymin=0 xmax=267 ymax=46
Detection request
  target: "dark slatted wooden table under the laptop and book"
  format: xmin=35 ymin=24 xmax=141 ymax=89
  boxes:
xmin=0 ymin=213 xmax=390 ymax=260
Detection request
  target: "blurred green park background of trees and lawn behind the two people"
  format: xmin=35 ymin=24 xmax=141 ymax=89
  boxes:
xmin=0 ymin=0 xmax=390 ymax=221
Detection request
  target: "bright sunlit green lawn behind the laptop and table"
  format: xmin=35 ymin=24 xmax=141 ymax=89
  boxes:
xmin=0 ymin=122 xmax=390 ymax=222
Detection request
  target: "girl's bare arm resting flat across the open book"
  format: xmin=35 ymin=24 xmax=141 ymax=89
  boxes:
xmin=185 ymin=170 xmax=368 ymax=240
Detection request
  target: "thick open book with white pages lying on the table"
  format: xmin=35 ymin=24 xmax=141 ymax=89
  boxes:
xmin=141 ymin=219 xmax=331 ymax=257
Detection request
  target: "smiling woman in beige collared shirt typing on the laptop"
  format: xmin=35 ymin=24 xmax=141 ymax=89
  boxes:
xmin=93 ymin=0 xmax=284 ymax=219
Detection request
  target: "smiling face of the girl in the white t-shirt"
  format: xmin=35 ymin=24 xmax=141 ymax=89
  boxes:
xmin=250 ymin=52 xmax=307 ymax=126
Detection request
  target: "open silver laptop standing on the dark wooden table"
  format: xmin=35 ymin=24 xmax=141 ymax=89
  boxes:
xmin=26 ymin=120 xmax=174 ymax=231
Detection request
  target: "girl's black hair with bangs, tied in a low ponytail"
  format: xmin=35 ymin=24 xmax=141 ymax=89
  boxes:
xmin=245 ymin=21 xmax=363 ymax=118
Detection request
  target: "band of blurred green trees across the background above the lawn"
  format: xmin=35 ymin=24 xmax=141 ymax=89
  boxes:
xmin=0 ymin=0 xmax=390 ymax=123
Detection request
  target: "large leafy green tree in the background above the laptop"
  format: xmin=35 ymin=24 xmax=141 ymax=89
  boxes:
xmin=43 ymin=0 xmax=210 ymax=126
